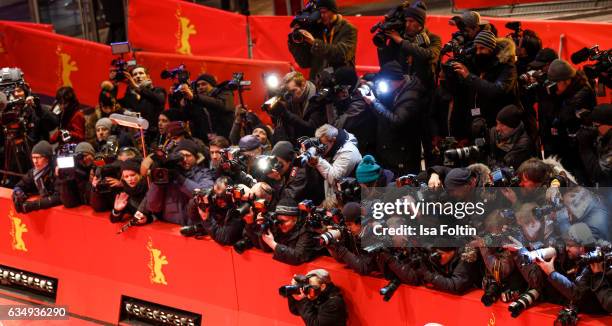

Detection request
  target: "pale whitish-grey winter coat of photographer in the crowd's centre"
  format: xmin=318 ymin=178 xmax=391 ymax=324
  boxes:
xmin=316 ymin=129 xmax=361 ymax=198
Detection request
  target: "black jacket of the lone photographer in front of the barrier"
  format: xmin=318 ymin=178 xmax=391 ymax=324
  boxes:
xmin=287 ymin=283 xmax=348 ymax=326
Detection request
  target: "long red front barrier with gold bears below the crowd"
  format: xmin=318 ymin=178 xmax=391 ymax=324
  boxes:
xmin=0 ymin=188 xmax=612 ymax=326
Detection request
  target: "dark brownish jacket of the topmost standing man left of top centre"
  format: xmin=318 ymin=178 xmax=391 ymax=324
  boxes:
xmin=288 ymin=15 xmax=357 ymax=80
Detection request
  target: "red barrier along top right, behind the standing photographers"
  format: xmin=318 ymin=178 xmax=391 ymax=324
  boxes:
xmin=249 ymin=16 xmax=612 ymax=66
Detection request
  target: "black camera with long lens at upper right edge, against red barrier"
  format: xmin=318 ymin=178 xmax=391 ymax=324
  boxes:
xmin=571 ymin=45 xmax=612 ymax=88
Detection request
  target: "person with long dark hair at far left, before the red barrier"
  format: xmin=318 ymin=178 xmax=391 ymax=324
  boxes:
xmin=49 ymin=86 xmax=85 ymax=144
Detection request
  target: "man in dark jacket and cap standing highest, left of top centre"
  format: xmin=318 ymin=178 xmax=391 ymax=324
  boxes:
xmin=288 ymin=0 xmax=357 ymax=80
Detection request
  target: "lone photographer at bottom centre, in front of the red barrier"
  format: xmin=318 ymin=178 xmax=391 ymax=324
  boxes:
xmin=287 ymin=269 xmax=348 ymax=326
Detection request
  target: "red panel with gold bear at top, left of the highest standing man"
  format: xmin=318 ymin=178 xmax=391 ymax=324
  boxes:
xmin=128 ymin=0 xmax=248 ymax=58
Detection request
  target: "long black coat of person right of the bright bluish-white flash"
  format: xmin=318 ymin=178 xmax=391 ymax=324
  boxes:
xmin=372 ymin=77 xmax=424 ymax=175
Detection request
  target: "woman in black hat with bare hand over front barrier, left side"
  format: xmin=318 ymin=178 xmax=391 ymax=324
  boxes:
xmin=109 ymin=160 xmax=148 ymax=224
